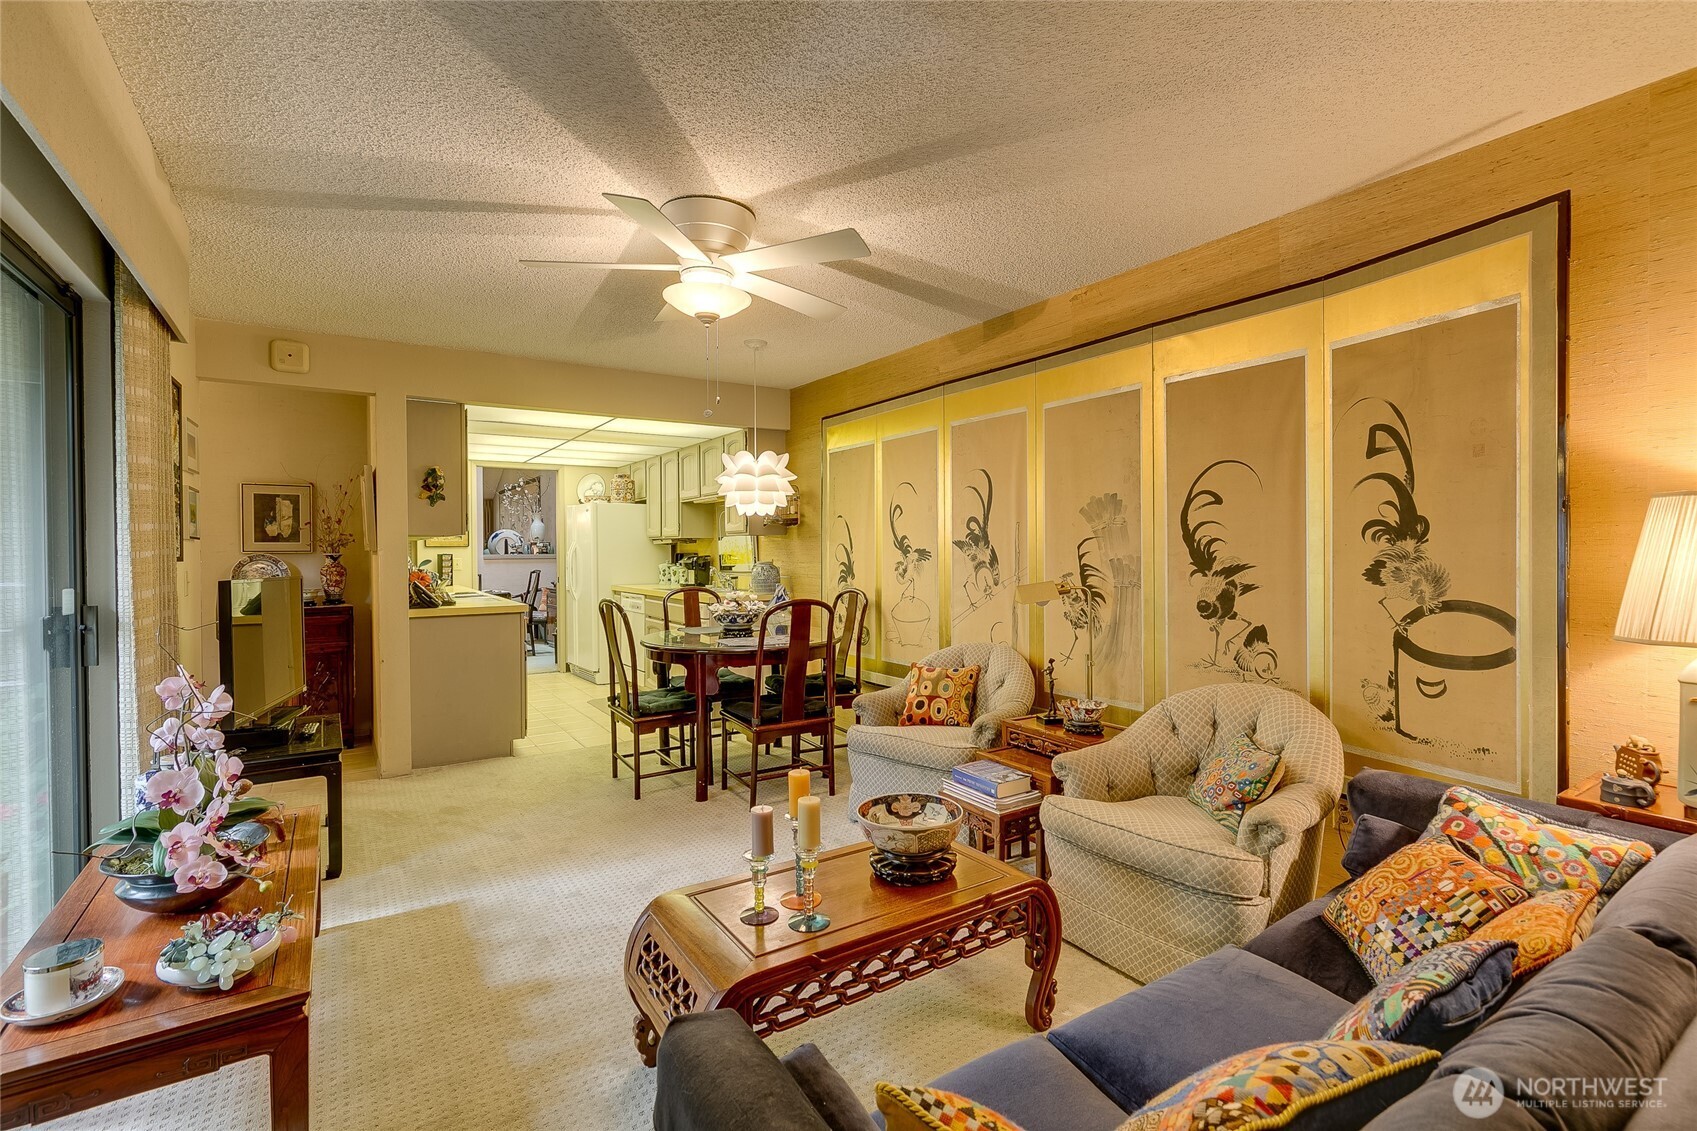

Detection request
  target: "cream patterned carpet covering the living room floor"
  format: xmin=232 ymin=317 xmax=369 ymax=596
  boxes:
xmin=53 ymin=672 xmax=1134 ymax=1131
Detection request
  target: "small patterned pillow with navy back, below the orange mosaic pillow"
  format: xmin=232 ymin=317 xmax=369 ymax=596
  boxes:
xmin=1325 ymin=930 xmax=1526 ymax=1049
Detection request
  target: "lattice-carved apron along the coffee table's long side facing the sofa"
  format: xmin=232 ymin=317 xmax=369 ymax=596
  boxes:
xmin=743 ymin=903 xmax=1030 ymax=1036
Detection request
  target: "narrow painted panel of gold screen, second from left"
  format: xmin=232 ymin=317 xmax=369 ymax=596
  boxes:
xmin=877 ymin=428 xmax=942 ymax=664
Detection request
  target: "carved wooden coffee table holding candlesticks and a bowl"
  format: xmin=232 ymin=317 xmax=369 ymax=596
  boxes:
xmin=624 ymin=844 xmax=1061 ymax=1068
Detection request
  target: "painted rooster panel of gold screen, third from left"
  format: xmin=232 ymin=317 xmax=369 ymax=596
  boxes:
xmin=949 ymin=409 xmax=1028 ymax=650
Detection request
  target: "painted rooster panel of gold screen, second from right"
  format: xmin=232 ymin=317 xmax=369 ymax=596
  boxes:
xmin=1166 ymin=353 xmax=1308 ymax=695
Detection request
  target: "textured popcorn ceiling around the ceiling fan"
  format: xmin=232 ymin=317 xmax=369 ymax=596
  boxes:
xmin=93 ymin=2 xmax=1697 ymax=385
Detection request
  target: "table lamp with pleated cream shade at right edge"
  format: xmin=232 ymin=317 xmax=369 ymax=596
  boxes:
xmin=1614 ymin=491 xmax=1697 ymax=805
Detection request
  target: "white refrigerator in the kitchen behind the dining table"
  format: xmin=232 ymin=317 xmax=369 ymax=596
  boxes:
xmin=560 ymin=503 xmax=658 ymax=683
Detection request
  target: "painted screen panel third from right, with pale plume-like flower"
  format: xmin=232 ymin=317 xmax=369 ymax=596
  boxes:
xmin=1032 ymin=387 xmax=1144 ymax=708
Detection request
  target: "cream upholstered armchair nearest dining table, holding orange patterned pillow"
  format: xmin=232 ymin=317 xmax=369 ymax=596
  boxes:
xmin=847 ymin=644 xmax=1037 ymax=813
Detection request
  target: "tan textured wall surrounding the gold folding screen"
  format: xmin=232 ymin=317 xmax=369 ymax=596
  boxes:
xmin=760 ymin=71 xmax=1697 ymax=779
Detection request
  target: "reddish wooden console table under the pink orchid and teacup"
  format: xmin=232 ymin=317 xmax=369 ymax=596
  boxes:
xmin=0 ymin=808 xmax=319 ymax=1131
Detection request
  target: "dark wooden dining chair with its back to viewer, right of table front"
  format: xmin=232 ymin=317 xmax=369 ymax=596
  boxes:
xmin=720 ymin=599 xmax=837 ymax=807
